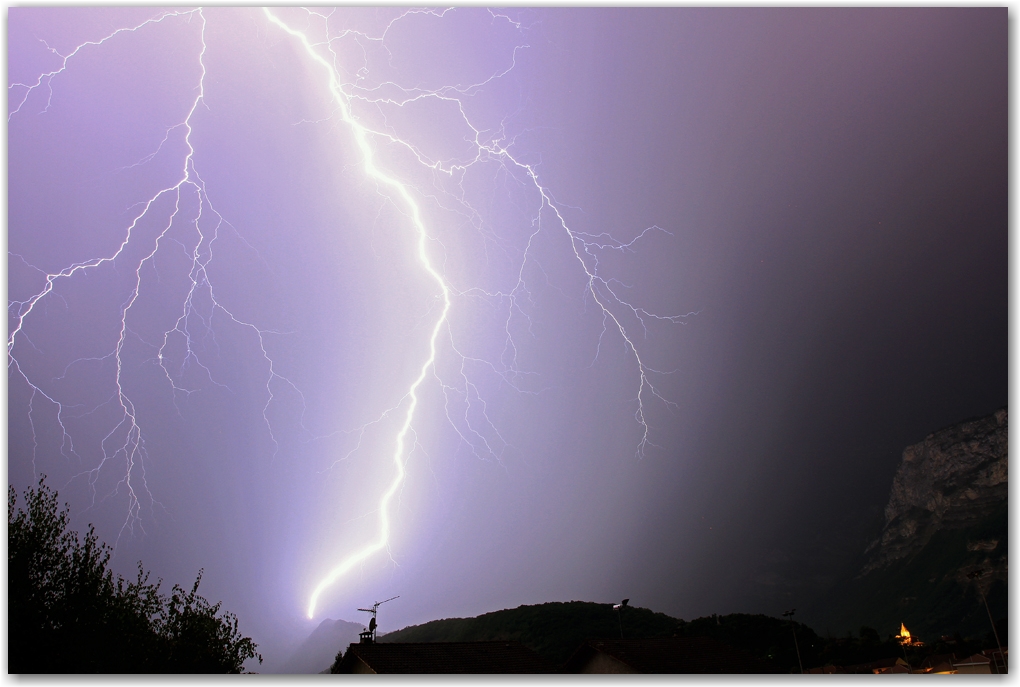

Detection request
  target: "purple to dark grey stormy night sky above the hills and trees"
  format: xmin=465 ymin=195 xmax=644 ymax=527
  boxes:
xmin=7 ymin=7 xmax=1008 ymax=667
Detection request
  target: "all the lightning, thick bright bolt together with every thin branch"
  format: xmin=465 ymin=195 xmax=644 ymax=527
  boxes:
xmin=7 ymin=9 xmax=693 ymax=618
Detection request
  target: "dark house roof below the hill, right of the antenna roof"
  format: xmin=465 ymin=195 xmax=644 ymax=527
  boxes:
xmin=563 ymin=637 xmax=780 ymax=674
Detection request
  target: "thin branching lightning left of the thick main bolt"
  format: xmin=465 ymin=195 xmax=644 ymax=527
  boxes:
xmin=7 ymin=9 xmax=301 ymax=540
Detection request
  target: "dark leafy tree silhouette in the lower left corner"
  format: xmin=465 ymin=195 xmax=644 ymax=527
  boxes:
xmin=7 ymin=478 xmax=262 ymax=674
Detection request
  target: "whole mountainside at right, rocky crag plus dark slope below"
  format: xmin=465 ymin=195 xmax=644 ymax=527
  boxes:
xmin=814 ymin=409 xmax=1009 ymax=641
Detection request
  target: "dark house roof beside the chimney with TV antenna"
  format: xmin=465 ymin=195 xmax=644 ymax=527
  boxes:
xmin=339 ymin=641 xmax=556 ymax=674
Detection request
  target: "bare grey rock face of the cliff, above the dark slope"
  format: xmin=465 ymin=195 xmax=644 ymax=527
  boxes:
xmin=861 ymin=408 xmax=1009 ymax=575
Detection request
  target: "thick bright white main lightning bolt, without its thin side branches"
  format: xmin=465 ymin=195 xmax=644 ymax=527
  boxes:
xmin=262 ymin=7 xmax=451 ymax=618
